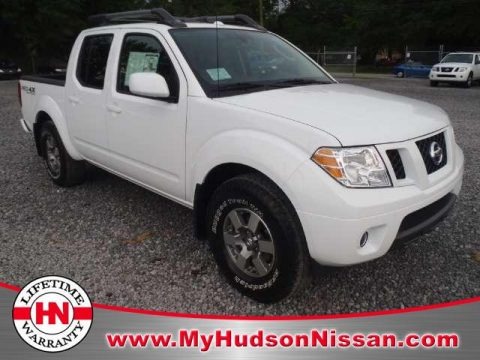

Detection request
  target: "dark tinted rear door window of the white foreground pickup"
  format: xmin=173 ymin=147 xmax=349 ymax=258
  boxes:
xmin=77 ymin=34 xmax=113 ymax=89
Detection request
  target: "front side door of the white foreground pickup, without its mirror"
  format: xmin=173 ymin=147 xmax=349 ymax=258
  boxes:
xmin=107 ymin=29 xmax=187 ymax=201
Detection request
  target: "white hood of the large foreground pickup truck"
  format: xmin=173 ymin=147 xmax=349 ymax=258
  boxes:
xmin=215 ymin=84 xmax=450 ymax=146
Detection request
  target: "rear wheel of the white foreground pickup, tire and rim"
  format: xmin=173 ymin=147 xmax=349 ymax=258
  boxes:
xmin=40 ymin=120 xmax=85 ymax=187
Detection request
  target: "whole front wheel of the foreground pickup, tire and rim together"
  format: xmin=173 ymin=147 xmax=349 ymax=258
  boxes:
xmin=207 ymin=174 xmax=310 ymax=303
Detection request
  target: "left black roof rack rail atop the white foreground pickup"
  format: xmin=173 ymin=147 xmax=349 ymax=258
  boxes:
xmin=88 ymin=8 xmax=187 ymax=27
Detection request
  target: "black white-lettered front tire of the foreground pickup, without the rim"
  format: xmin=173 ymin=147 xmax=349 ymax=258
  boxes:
xmin=206 ymin=173 xmax=310 ymax=303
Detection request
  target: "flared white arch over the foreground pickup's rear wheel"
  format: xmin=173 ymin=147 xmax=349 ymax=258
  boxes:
xmin=35 ymin=95 xmax=83 ymax=160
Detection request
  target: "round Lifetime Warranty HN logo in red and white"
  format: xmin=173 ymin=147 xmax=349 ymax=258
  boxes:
xmin=12 ymin=276 xmax=93 ymax=352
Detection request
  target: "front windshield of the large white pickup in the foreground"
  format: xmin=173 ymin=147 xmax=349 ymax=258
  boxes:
xmin=170 ymin=28 xmax=332 ymax=97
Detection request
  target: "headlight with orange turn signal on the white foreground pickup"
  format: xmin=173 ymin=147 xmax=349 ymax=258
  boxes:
xmin=312 ymin=146 xmax=392 ymax=188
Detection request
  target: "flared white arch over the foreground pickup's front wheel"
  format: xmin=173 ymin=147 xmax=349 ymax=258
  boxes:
xmin=187 ymin=129 xmax=328 ymax=212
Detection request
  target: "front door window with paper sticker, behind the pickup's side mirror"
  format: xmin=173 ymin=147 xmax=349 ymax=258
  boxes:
xmin=117 ymin=34 xmax=179 ymax=100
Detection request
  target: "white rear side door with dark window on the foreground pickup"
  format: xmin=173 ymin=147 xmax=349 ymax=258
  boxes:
xmin=65 ymin=32 xmax=114 ymax=163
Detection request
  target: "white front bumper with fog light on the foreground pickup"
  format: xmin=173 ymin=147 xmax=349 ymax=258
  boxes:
xmin=290 ymin=135 xmax=464 ymax=266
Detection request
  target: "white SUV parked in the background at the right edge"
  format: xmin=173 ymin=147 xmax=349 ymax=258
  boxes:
xmin=429 ymin=52 xmax=480 ymax=88
